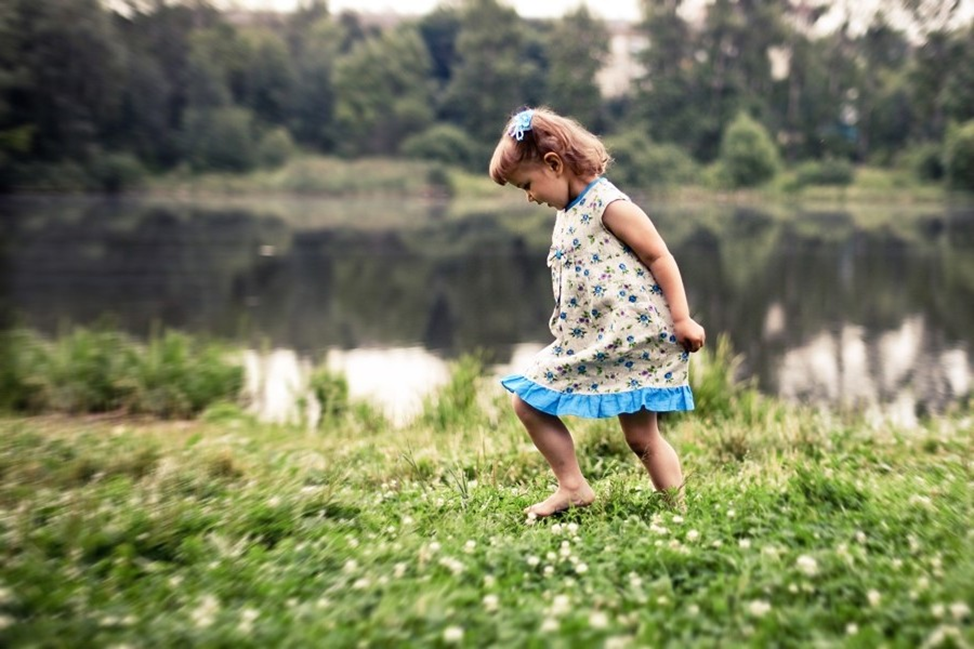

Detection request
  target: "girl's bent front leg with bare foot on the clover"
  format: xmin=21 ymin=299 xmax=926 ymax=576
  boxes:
xmin=511 ymin=395 xmax=595 ymax=516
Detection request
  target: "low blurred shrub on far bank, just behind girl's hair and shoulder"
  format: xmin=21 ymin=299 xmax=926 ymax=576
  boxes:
xmin=605 ymin=131 xmax=698 ymax=188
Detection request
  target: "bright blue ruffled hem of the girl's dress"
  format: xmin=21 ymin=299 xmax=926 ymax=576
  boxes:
xmin=501 ymin=374 xmax=693 ymax=419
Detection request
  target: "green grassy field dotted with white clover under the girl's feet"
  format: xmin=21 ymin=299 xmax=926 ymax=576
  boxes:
xmin=0 ymin=350 xmax=974 ymax=647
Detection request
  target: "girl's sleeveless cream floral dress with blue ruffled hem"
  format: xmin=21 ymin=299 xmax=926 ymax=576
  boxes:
xmin=501 ymin=178 xmax=693 ymax=418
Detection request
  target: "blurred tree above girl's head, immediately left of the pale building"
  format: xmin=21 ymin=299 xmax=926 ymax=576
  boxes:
xmin=546 ymin=5 xmax=609 ymax=128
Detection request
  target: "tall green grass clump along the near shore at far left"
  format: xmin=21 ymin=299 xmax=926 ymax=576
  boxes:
xmin=0 ymin=327 xmax=243 ymax=418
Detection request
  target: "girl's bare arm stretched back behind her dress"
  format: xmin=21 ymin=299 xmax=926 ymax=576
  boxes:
xmin=602 ymin=201 xmax=706 ymax=352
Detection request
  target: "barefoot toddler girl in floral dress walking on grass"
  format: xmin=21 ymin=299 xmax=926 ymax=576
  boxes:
xmin=490 ymin=108 xmax=705 ymax=517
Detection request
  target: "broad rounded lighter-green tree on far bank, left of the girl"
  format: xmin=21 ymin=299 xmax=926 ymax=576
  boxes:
xmin=335 ymin=27 xmax=433 ymax=154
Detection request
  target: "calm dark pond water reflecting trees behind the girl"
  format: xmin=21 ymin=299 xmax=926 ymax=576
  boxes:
xmin=0 ymin=198 xmax=974 ymax=419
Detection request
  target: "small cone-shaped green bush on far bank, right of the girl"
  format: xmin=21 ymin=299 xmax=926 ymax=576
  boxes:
xmin=720 ymin=113 xmax=779 ymax=187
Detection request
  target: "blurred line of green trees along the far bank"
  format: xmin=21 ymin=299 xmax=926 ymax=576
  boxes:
xmin=0 ymin=0 xmax=974 ymax=191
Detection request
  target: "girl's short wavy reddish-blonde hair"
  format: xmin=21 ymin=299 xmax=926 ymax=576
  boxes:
xmin=490 ymin=107 xmax=612 ymax=185
